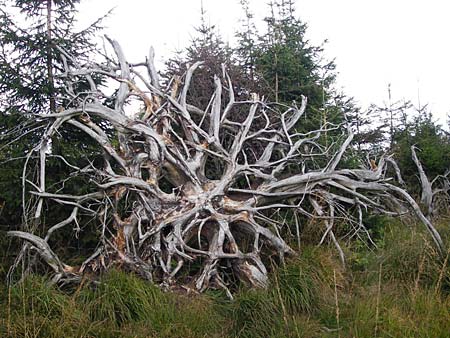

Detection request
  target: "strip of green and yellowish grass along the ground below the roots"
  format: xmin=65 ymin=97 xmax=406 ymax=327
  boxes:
xmin=0 ymin=219 xmax=450 ymax=337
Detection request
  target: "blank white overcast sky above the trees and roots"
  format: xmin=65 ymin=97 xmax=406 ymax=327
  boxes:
xmin=79 ymin=0 xmax=450 ymax=125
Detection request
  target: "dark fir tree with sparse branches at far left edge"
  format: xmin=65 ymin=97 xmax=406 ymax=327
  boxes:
xmin=0 ymin=0 xmax=101 ymax=230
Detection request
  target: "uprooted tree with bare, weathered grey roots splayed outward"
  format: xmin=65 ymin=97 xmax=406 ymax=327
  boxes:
xmin=9 ymin=40 xmax=442 ymax=291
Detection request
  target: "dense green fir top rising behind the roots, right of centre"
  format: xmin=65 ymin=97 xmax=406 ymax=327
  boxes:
xmin=256 ymin=1 xmax=334 ymax=103
